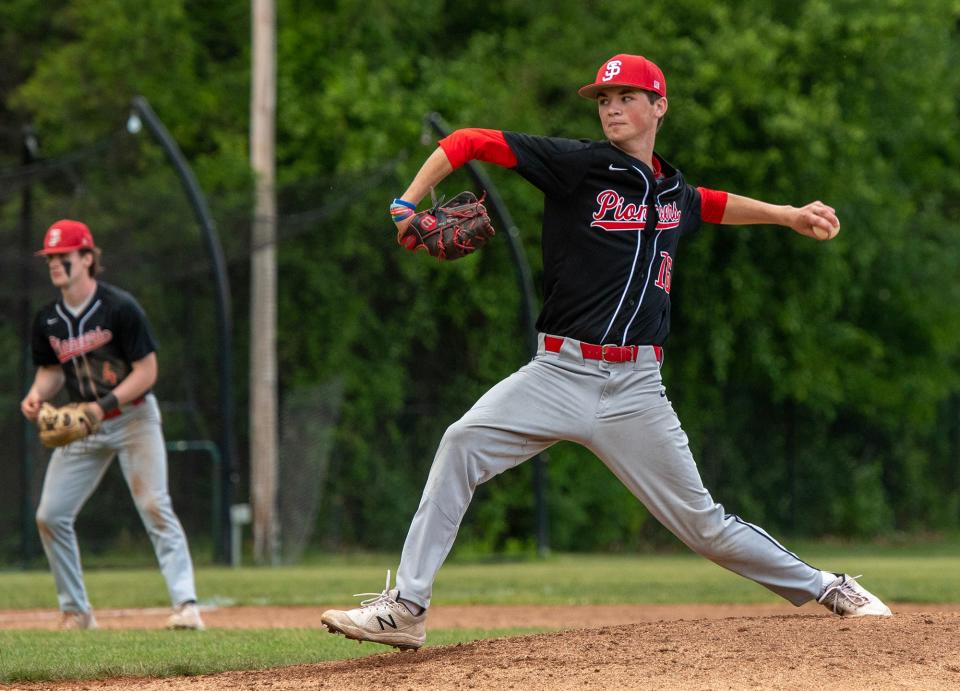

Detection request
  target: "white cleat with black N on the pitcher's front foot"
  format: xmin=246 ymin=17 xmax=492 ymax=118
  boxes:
xmin=320 ymin=571 xmax=427 ymax=650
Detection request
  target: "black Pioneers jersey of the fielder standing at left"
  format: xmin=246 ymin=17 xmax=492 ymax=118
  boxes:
xmin=32 ymin=281 xmax=157 ymax=401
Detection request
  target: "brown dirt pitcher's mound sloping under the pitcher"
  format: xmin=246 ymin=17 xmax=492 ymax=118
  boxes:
xmin=30 ymin=612 xmax=960 ymax=691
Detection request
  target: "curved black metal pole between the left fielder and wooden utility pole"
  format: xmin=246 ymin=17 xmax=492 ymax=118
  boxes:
xmin=128 ymin=96 xmax=237 ymax=564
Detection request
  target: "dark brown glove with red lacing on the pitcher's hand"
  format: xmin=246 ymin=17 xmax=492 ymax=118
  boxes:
xmin=397 ymin=192 xmax=496 ymax=260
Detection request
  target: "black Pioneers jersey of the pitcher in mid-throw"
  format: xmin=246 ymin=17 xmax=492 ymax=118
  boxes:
xmin=503 ymin=132 xmax=701 ymax=345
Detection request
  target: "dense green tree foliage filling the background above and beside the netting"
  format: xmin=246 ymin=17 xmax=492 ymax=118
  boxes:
xmin=0 ymin=0 xmax=960 ymax=550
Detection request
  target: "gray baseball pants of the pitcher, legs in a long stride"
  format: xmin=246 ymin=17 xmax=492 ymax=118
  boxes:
xmin=397 ymin=334 xmax=821 ymax=607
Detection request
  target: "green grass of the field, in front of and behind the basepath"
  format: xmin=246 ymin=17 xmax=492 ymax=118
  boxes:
xmin=0 ymin=541 xmax=960 ymax=682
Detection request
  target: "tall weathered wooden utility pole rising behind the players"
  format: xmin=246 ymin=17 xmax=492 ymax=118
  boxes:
xmin=250 ymin=0 xmax=279 ymax=564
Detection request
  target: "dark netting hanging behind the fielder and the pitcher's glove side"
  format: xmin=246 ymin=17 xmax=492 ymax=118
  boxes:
xmin=0 ymin=115 xmax=548 ymax=566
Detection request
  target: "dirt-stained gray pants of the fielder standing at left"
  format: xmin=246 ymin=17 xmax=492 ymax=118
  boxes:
xmin=37 ymin=394 xmax=197 ymax=612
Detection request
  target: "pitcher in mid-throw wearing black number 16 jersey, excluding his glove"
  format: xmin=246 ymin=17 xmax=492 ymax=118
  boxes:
xmin=323 ymin=55 xmax=890 ymax=648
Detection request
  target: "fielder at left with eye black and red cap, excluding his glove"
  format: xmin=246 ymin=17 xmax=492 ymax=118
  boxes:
xmin=20 ymin=219 xmax=203 ymax=629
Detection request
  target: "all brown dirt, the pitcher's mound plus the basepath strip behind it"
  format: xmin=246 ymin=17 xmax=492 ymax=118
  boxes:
xmin=7 ymin=604 xmax=960 ymax=691
